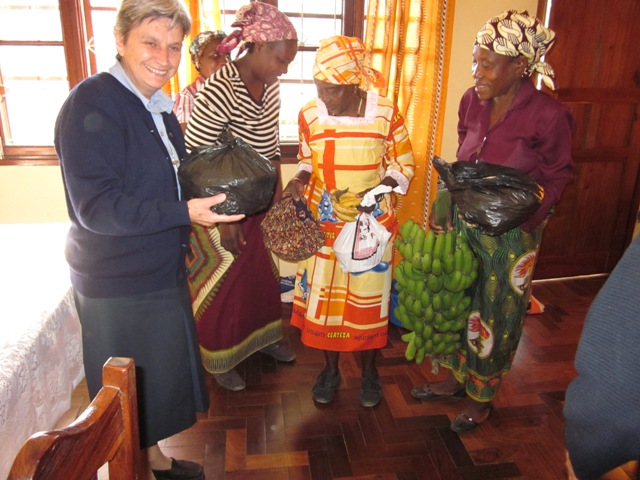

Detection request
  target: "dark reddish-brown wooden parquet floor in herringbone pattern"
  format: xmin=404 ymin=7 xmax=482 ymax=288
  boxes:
xmin=62 ymin=277 xmax=624 ymax=480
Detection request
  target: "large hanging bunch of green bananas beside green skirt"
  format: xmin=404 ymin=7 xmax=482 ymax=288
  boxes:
xmin=393 ymin=220 xmax=478 ymax=370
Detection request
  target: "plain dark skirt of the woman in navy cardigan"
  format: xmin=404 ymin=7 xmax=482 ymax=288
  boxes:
xmin=75 ymin=286 xmax=209 ymax=448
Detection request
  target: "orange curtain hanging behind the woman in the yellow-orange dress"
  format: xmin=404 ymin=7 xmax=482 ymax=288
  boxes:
xmin=363 ymin=0 xmax=454 ymax=232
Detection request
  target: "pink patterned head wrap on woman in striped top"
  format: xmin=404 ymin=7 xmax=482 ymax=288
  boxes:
xmin=218 ymin=2 xmax=298 ymax=54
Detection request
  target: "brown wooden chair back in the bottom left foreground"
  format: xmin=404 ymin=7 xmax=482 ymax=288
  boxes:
xmin=7 ymin=357 xmax=140 ymax=480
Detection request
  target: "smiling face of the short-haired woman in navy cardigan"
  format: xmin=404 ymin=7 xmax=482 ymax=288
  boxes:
xmin=115 ymin=17 xmax=184 ymax=98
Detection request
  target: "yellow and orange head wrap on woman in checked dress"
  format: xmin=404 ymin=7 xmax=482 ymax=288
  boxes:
xmin=312 ymin=35 xmax=384 ymax=87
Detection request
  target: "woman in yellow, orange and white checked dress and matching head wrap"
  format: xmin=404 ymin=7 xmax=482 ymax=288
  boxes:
xmin=285 ymin=36 xmax=414 ymax=407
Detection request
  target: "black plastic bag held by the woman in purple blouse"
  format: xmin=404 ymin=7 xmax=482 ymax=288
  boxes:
xmin=433 ymin=157 xmax=544 ymax=235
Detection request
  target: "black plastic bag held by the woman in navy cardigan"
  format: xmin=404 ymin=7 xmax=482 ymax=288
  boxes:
xmin=178 ymin=130 xmax=277 ymax=215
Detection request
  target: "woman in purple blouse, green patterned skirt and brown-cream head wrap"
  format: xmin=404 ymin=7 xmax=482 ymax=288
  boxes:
xmin=412 ymin=10 xmax=573 ymax=433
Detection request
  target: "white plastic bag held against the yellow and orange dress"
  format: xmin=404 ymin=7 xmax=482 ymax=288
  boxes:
xmin=333 ymin=212 xmax=391 ymax=273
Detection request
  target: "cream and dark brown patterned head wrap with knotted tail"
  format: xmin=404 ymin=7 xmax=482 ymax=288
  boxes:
xmin=475 ymin=10 xmax=556 ymax=90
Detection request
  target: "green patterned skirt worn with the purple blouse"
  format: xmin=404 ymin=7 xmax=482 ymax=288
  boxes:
xmin=441 ymin=216 xmax=543 ymax=402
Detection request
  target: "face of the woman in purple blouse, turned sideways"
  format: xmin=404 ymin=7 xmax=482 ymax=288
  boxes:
xmin=471 ymin=45 xmax=526 ymax=100
